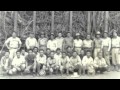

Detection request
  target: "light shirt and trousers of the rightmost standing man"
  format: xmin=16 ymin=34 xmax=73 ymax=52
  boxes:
xmin=112 ymin=36 xmax=120 ymax=65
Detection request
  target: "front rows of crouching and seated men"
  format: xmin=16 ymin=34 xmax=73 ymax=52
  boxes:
xmin=1 ymin=48 xmax=108 ymax=76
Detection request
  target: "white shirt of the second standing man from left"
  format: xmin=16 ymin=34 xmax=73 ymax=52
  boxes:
xmin=25 ymin=37 xmax=38 ymax=49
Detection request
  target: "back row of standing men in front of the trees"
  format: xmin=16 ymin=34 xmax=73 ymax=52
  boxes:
xmin=5 ymin=30 xmax=120 ymax=71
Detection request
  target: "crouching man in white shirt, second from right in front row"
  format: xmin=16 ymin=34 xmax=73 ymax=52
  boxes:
xmin=82 ymin=51 xmax=94 ymax=75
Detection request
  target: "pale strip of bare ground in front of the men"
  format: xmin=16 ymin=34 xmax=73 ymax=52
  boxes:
xmin=0 ymin=71 xmax=120 ymax=79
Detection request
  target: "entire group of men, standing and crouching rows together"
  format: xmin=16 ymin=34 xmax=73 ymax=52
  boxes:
xmin=1 ymin=30 xmax=120 ymax=75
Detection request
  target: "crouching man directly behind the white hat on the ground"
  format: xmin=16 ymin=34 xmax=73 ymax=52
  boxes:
xmin=69 ymin=51 xmax=82 ymax=75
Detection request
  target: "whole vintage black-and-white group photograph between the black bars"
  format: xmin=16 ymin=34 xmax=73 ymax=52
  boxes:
xmin=0 ymin=11 xmax=120 ymax=79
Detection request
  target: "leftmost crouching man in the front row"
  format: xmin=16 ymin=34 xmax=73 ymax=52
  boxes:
xmin=0 ymin=52 xmax=12 ymax=73
